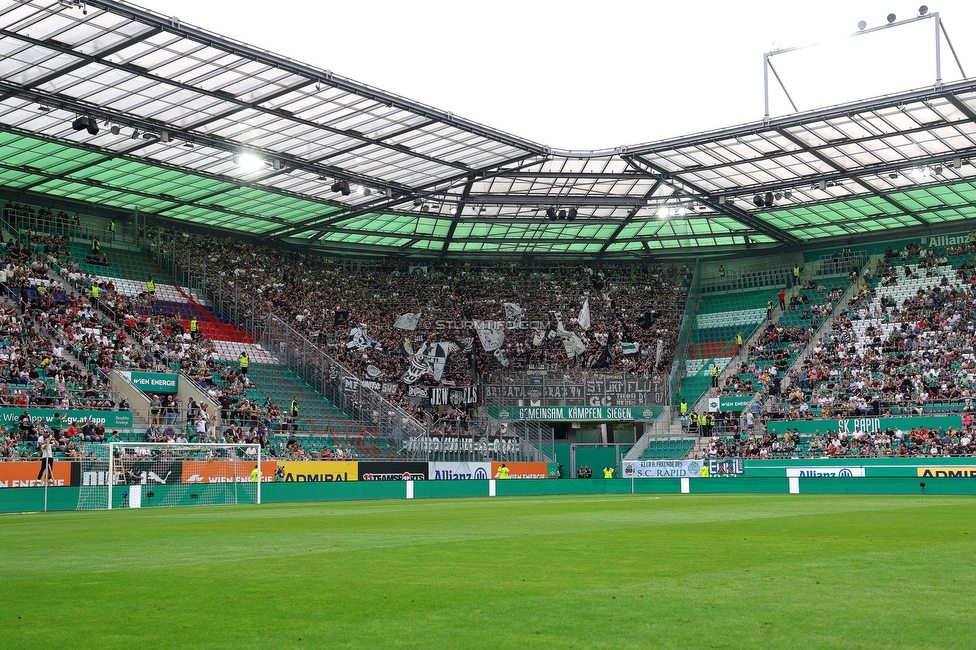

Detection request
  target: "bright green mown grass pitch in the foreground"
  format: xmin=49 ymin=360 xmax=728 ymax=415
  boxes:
xmin=0 ymin=495 xmax=976 ymax=650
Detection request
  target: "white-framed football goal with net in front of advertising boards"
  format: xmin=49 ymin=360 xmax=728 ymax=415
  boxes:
xmin=78 ymin=442 xmax=264 ymax=510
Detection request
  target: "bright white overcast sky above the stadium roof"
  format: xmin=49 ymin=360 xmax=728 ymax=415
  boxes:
xmin=138 ymin=0 xmax=976 ymax=149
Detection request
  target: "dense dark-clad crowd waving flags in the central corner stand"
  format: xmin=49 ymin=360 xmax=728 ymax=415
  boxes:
xmin=158 ymin=232 xmax=689 ymax=384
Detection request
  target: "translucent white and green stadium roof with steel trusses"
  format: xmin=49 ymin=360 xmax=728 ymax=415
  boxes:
xmin=0 ymin=0 xmax=976 ymax=258
